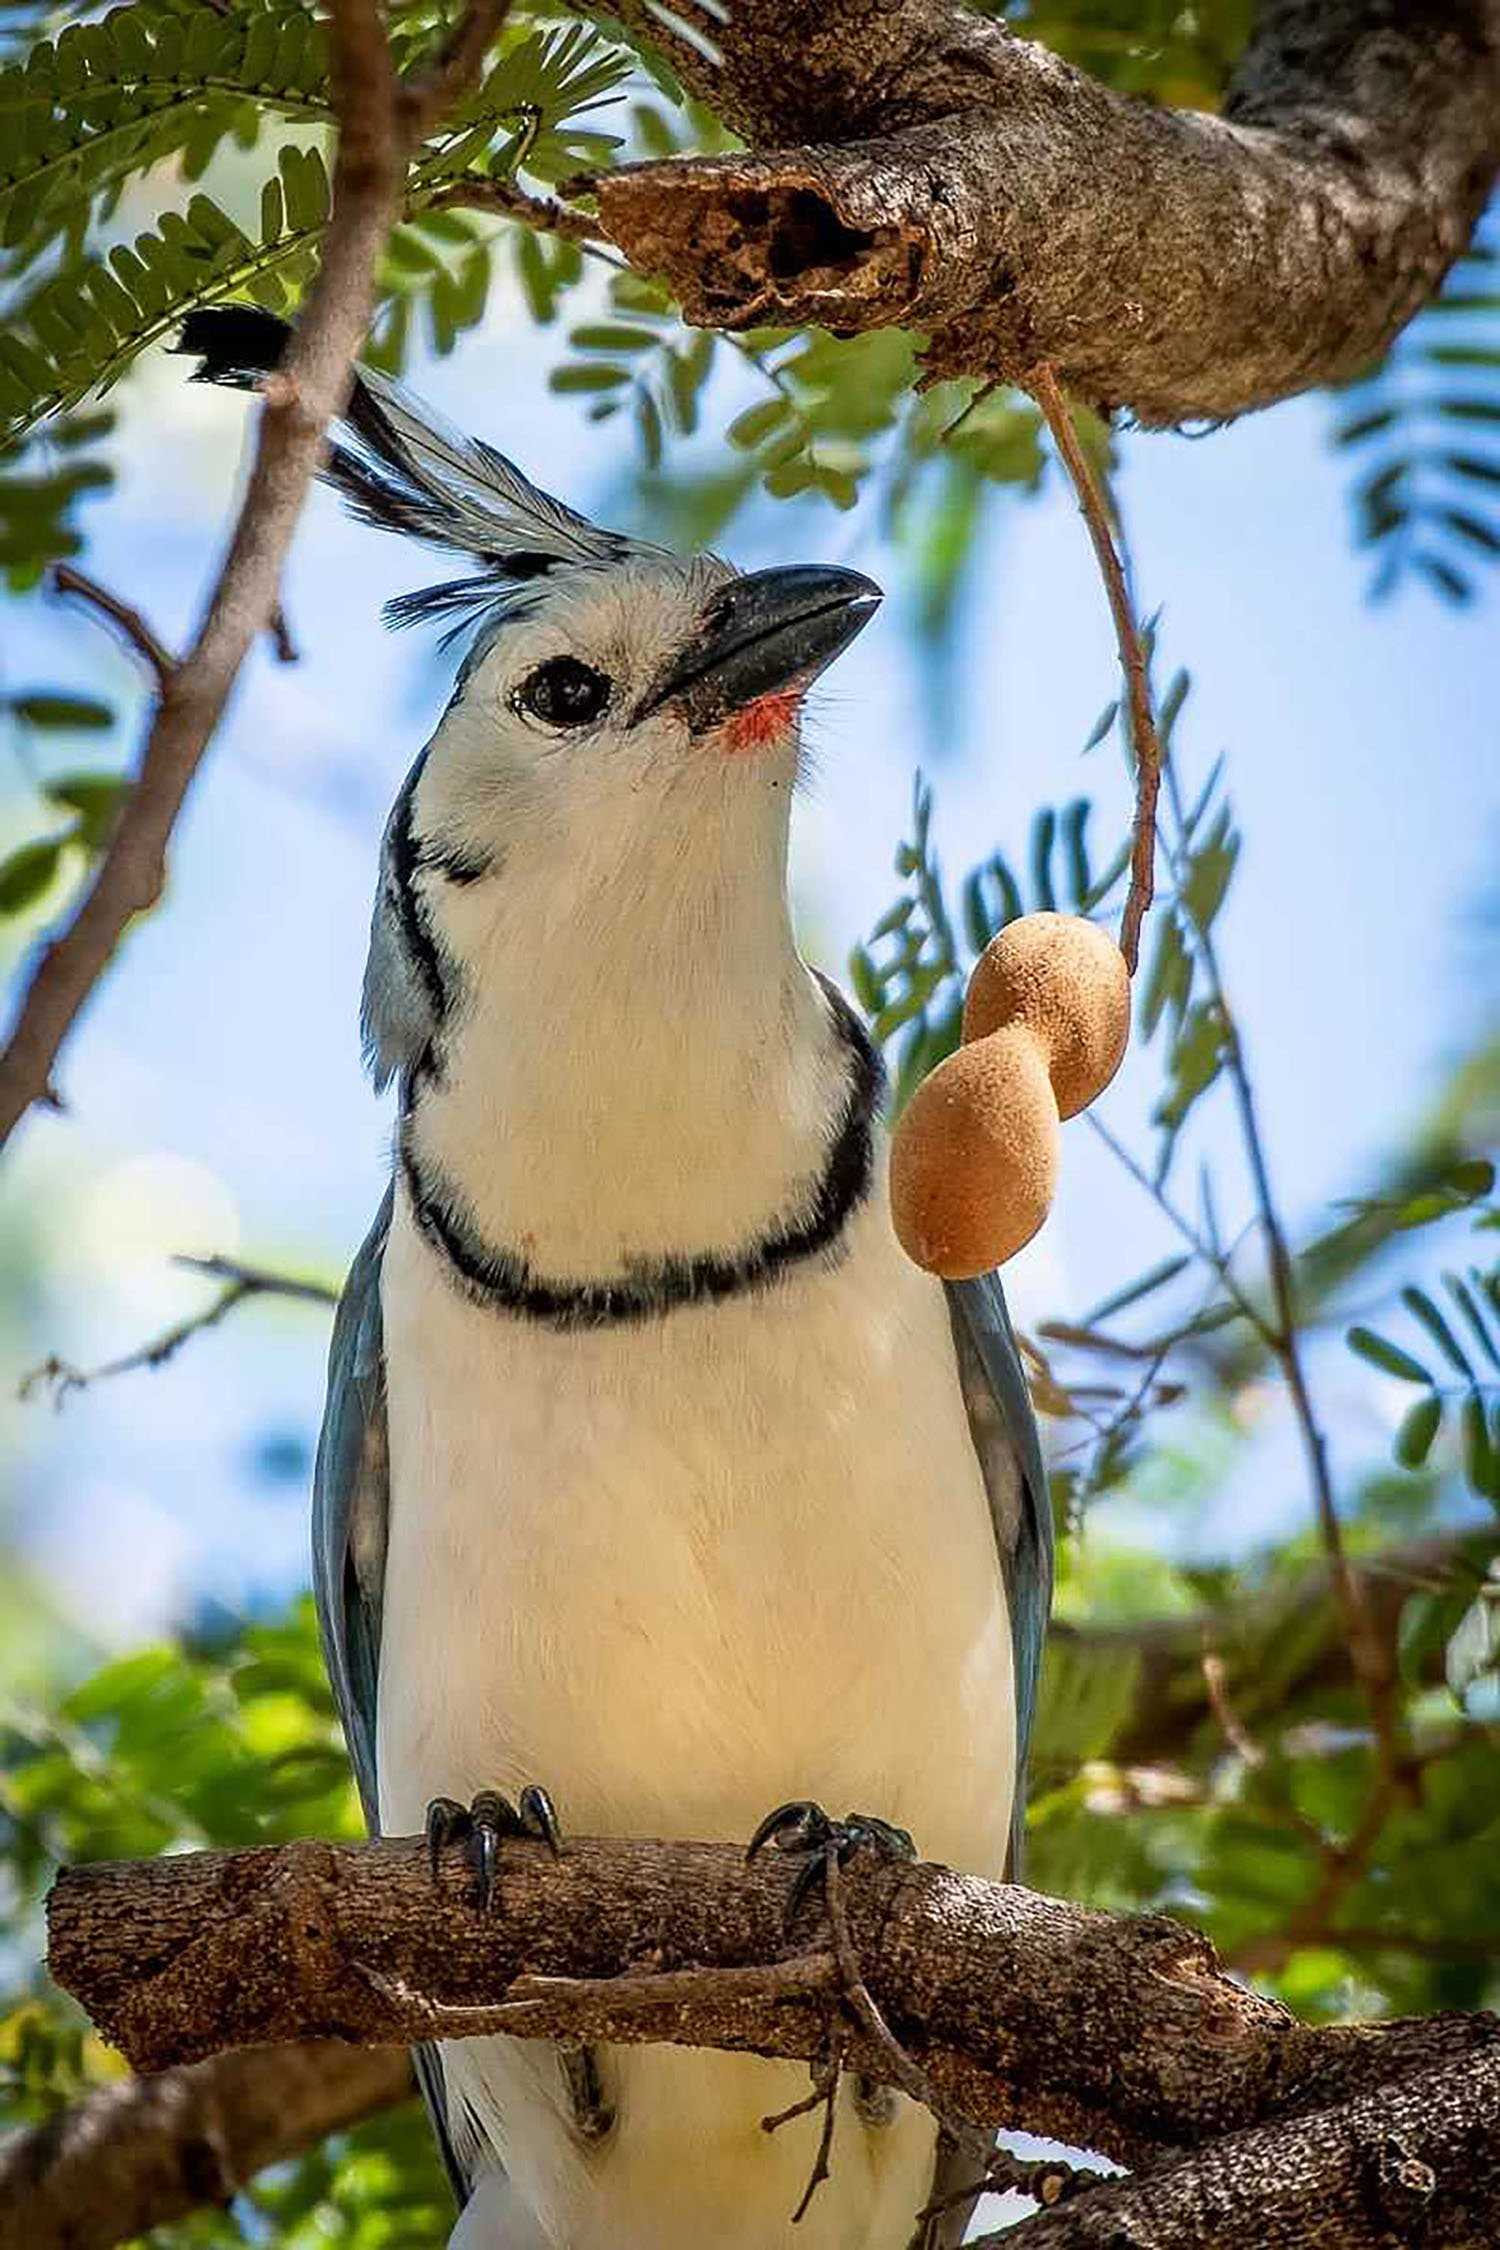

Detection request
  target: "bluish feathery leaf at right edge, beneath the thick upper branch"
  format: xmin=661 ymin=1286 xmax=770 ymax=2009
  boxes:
xmin=1334 ymin=223 xmax=1500 ymax=601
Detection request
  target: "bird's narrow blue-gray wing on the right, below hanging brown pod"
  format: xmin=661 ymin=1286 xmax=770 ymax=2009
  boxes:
xmin=947 ymin=1274 xmax=1052 ymax=1881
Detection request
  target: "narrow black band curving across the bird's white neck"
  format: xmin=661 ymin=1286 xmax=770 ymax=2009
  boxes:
xmin=400 ymin=979 xmax=886 ymax=1330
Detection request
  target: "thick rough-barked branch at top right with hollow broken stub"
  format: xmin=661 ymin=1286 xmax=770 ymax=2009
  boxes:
xmin=594 ymin=0 xmax=1500 ymax=423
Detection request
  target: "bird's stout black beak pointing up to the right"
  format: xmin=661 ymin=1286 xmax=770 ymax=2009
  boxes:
xmin=636 ymin=563 xmax=882 ymax=734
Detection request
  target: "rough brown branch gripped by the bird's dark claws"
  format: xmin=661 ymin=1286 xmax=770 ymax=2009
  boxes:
xmin=49 ymin=1838 xmax=1500 ymax=2178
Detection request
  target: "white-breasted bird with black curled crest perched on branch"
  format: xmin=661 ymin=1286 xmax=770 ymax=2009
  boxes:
xmin=180 ymin=306 xmax=1052 ymax=2250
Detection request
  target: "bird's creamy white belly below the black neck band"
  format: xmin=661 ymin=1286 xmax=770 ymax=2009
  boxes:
xmin=378 ymin=1195 xmax=1014 ymax=2250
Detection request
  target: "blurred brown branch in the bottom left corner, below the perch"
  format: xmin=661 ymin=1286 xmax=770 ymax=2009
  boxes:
xmin=0 ymin=2041 xmax=412 ymax=2250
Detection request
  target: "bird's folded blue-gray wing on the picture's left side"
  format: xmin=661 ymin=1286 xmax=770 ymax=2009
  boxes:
xmin=313 ymin=1188 xmax=468 ymax=2203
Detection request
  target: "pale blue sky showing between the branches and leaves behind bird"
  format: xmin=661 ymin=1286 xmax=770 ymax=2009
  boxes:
xmin=0 ymin=290 xmax=1500 ymax=1640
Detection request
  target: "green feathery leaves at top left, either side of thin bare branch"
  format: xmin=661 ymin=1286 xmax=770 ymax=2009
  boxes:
xmin=0 ymin=17 xmax=632 ymax=439
